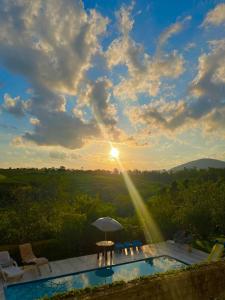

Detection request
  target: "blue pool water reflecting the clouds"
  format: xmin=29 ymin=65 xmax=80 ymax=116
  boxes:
xmin=5 ymin=256 xmax=186 ymax=300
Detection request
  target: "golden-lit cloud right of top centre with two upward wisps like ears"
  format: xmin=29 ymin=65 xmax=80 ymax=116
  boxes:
xmin=105 ymin=8 xmax=185 ymax=100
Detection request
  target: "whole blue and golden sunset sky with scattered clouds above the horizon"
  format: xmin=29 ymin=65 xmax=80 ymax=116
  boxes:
xmin=0 ymin=0 xmax=225 ymax=170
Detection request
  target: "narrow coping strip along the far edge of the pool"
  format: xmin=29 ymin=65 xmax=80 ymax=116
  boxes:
xmin=3 ymin=255 xmax=190 ymax=300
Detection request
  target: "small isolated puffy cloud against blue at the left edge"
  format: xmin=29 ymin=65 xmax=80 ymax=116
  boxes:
xmin=1 ymin=94 xmax=29 ymax=118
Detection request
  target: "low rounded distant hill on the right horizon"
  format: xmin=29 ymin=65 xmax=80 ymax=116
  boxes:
xmin=171 ymin=158 xmax=225 ymax=172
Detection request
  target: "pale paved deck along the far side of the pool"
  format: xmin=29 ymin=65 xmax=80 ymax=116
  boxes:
xmin=0 ymin=241 xmax=208 ymax=300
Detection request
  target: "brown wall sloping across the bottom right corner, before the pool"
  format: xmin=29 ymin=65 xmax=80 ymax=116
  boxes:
xmin=79 ymin=261 xmax=225 ymax=300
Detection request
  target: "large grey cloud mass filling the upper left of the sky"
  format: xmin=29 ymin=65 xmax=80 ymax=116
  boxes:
xmin=0 ymin=0 xmax=108 ymax=148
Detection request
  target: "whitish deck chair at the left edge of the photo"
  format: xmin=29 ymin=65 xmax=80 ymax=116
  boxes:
xmin=0 ymin=251 xmax=24 ymax=282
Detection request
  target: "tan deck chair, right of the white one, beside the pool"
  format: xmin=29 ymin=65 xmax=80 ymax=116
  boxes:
xmin=19 ymin=243 xmax=52 ymax=275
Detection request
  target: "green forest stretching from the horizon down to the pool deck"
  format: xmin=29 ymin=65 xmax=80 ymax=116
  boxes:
xmin=0 ymin=167 xmax=225 ymax=260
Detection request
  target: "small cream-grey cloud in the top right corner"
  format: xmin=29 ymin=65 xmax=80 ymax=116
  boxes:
xmin=202 ymin=3 xmax=225 ymax=27
